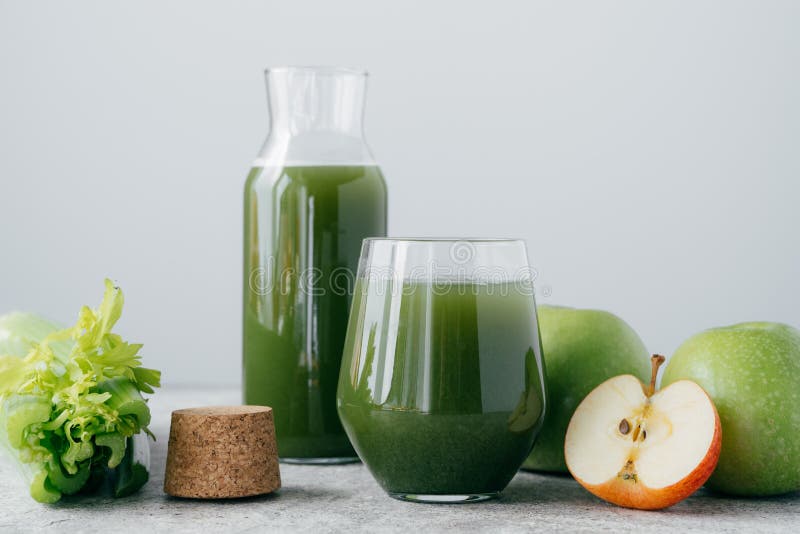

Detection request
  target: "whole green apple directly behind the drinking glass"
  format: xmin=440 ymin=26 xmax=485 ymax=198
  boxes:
xmin=522 ymin=306 xmax=650 ymax=473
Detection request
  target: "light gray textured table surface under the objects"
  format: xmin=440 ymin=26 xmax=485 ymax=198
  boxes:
xmin=0 ymin=389 xmax=800 ymax=533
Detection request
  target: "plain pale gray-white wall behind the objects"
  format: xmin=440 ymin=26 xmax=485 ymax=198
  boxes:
xmin=0 ymin=0 xmax=800 ymax=385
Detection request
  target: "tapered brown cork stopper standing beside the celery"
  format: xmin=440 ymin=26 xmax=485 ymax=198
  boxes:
xmin=164 ymin=406 xmax=281 ymax=499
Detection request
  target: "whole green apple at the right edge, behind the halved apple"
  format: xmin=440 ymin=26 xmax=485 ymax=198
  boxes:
xmin=661 ymin=323 xmax=800 ymax=496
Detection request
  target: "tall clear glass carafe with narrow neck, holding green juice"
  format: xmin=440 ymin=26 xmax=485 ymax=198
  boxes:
xmin=243 ymin=67 xmax=387 ymax=463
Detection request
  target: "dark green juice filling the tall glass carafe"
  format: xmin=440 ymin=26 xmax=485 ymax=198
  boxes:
xmin=243 ymin=165 xmax=386 ymax=461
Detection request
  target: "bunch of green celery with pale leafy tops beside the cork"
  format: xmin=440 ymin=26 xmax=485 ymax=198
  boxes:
xmin=0 ymin=280 xmax=160 ymax=502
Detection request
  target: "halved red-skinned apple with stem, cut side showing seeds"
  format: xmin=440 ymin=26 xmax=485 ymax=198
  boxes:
xmin=564 ymin=355 xmax=722 ymax=510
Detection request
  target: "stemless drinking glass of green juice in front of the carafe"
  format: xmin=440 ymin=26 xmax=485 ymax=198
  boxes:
xmin=337 ymin=238 xmax=546 ymax=502
